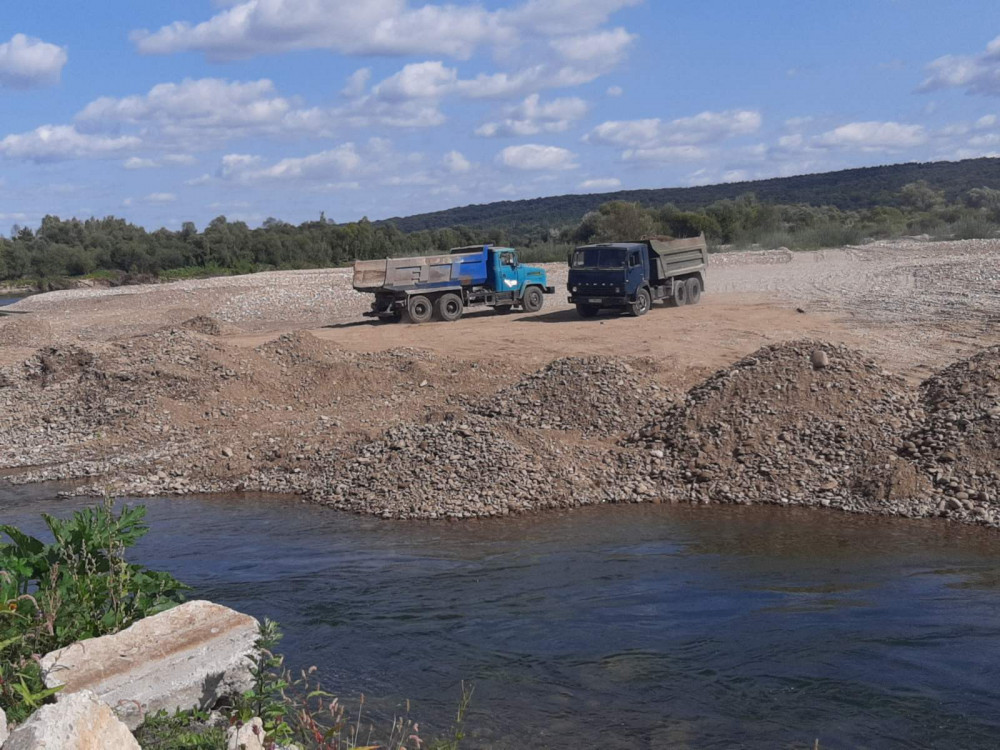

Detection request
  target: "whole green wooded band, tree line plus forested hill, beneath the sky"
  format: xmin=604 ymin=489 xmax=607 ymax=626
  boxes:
xmin=0 ymin=159 xmax=1000 ymax=289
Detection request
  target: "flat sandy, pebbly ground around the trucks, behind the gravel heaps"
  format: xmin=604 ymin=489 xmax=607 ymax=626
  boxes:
xmin=0 ymin=240 xmax=1000 ymax=386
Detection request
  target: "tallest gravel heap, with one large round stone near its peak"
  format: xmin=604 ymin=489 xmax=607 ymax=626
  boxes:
xmin=619 ymin=341 xmax=938 ymax=516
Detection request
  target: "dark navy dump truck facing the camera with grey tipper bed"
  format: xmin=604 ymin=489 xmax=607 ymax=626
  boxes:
xmin=568 ymin=235 xmax=708 ymax=318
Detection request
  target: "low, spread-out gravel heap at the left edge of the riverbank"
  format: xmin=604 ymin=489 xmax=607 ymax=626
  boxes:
xmin=0 ymin=329 xmax=236 ymax=480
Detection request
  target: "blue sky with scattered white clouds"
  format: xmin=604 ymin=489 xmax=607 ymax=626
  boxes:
xmin=0 ymin=0 xmax=1000 ymax=231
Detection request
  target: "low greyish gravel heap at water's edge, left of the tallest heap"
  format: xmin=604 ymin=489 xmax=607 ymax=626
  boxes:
xmin=313 ymin=416 xmax=592 ymax=519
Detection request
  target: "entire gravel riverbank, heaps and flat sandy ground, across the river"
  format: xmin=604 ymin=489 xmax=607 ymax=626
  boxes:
xmin=0 ymin=243 xmax=1000 ymax=526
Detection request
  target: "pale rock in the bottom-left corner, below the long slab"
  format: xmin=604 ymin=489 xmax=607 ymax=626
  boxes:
xmin=3 ymin=690 xmax=140 ymax=750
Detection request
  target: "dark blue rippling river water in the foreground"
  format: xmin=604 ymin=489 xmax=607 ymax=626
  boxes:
xmin=0 ymin=487 xmax=1000 ymax=750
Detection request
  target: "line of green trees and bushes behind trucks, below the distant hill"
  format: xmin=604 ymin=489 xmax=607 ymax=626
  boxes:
xmin=0 ymin=181 xmax=1000 ymax=281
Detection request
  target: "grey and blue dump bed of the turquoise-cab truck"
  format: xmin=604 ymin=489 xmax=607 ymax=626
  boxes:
xmin=354 ymin=245 xmax=489 ymax=292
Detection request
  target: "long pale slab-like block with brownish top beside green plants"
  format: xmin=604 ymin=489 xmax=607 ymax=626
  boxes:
xmin=42 ymin=601 xmax=257 ymax=729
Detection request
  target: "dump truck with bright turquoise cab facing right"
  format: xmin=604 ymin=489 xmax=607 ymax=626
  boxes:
xmin=354 ymin=245 xmax=555 ymax=323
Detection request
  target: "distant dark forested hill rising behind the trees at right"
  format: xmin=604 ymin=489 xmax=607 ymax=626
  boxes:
xmin=379 ymin=158 xmax=1000 ymax=232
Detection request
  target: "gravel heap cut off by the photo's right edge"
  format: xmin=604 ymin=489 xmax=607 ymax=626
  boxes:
xmin=900 ymin=346 xmax=1000 ymax=521
